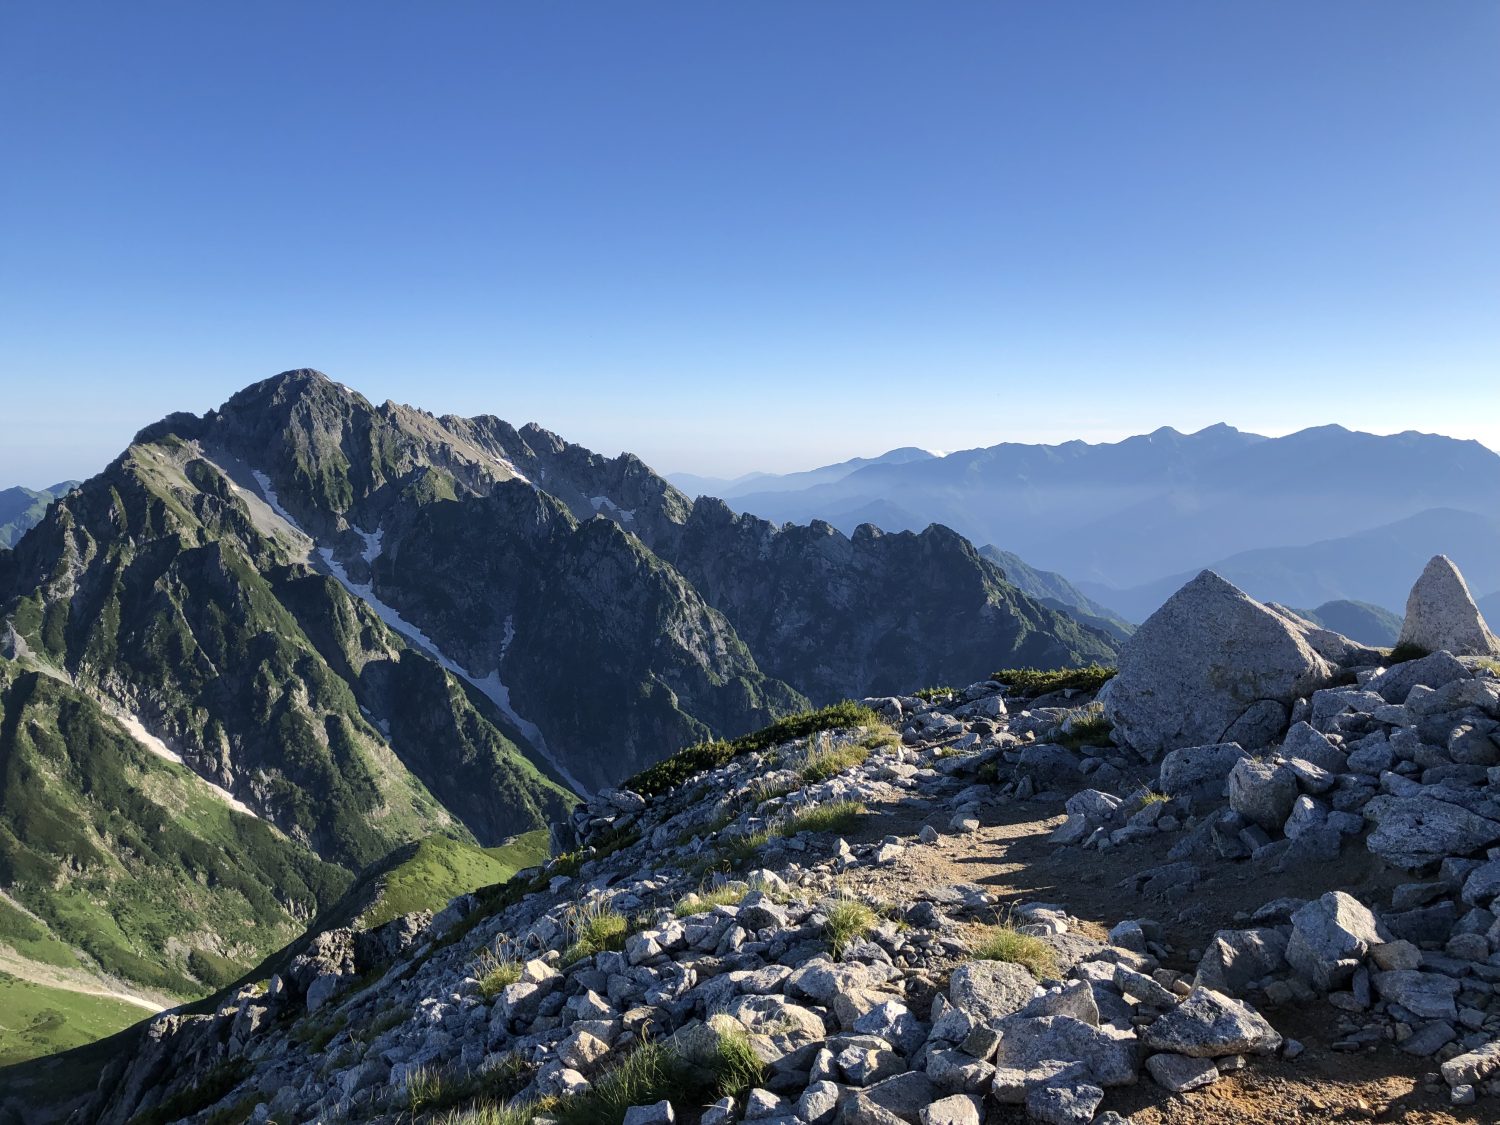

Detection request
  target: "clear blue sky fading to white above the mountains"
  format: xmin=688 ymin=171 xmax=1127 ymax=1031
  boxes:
xmin=0 ymin=0 xmax=1500 ymax=486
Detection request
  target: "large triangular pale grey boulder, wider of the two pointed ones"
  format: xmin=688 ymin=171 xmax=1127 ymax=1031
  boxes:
xmin=1100 ymin=570 xmax=1334 ymax=758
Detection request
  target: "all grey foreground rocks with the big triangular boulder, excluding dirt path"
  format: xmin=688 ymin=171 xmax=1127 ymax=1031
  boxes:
xmin=78 ymin=567 xmax=1500 ymax=1125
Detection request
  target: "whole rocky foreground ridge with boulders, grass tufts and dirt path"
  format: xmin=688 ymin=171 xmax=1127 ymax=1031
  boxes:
xmin=26 ymin=560 xmax=1500 ymax=1125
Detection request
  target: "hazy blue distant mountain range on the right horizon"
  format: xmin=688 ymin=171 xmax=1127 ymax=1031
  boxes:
xmin=678 ymin=425 xmax=1500 ymax=621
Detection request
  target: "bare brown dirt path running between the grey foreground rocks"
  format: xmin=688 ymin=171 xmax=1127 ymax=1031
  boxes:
xmin=849 ymin=798 xmax=1476 ymax=1125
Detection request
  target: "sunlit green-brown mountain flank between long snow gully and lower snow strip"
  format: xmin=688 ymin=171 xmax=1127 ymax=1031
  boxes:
xmin=6 ymin=435 xmax=569 ymax=869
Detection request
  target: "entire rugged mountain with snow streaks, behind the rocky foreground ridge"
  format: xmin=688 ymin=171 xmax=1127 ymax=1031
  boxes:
xmin=0 ymin=371 xmax=1115 ymax=1038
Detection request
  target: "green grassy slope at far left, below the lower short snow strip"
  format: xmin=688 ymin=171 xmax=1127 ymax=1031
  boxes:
xmin=0 ymin=660 xmax=350 ymax=996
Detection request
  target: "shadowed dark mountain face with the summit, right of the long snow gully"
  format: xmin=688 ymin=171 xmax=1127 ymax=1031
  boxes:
xmin=172 ymin=372 xmax=1113 ymax=759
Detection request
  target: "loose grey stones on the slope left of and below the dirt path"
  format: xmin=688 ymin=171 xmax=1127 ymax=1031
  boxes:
xmin=90 ymin=684 xmax=1281 ymax=1125
